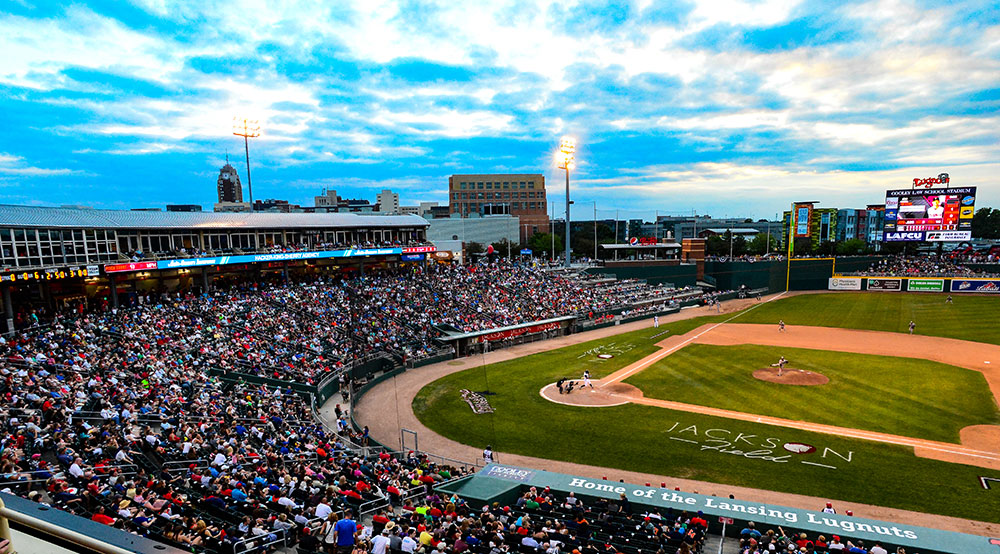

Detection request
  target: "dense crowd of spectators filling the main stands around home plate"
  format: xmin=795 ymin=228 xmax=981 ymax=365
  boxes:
xmin=0 ymin=261 xmax=752 ymax=554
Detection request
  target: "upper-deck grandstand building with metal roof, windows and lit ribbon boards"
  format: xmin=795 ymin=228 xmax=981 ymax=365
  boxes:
xmin=0 ymin=205 xmax=435 ymax=329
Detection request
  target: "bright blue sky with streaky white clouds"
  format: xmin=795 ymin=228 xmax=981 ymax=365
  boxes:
xmin=0 ymin=0 xmax=1000 ymax=219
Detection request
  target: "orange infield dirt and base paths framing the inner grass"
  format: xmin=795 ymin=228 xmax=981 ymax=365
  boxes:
xmin=541 ymin=323 xmax=1000 ymax=470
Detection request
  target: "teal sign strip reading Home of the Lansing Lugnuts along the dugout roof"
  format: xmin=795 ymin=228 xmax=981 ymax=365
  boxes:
xmin=472 ymin=462 xmax=996 ymax=554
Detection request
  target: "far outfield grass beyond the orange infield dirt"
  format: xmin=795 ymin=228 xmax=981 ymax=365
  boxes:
xmin=736 ymin=292 xmax=1000 ymax=344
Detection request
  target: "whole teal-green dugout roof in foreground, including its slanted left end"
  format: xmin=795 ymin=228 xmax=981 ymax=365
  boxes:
xmin=438 ymin=464 xmax=997 ymax=554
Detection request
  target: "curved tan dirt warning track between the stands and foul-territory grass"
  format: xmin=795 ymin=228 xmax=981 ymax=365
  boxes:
xmin=350 ymin=295 xmax=1000 ymax=536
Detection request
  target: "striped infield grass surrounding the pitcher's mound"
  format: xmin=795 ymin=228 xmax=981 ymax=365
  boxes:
xmin=625 ymin=342 xmax=1000 ymax=443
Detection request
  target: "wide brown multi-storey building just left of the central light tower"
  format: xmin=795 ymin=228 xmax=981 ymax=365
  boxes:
xmin=448 ymin=173 xmax=549 ymax=241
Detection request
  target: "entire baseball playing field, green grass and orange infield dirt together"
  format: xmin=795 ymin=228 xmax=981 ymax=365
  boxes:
xmin=412 ymin=293 xmax=1000 ymax=523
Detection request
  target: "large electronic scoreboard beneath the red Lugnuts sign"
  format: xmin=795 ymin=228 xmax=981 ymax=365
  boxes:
xmin=883 ymin=187 xmax=976 ymax=242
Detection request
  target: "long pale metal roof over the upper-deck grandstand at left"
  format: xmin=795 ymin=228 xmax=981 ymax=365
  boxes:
xmin=0 ymin=204 xmax=429 ymax=229
